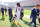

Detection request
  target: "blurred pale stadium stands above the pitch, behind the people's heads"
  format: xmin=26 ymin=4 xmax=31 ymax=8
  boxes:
xmin=0 ymin=0 xmax=40 ymax=10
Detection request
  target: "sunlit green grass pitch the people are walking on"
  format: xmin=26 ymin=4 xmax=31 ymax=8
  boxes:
xmin=0 ymin=10 xmax=40 ymax=27
